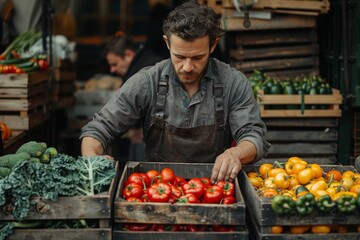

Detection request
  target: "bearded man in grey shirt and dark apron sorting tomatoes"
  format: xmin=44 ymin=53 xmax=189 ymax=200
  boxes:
xmin=80 ymin=1 xmax=270 ymax=182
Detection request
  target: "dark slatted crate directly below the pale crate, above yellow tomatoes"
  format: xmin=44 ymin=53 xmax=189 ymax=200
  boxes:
xmin=258 ymin=118 xmax=339 ymax=165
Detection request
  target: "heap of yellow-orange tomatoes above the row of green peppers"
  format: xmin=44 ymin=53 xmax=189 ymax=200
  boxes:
xmin=247 ymin=157 xmax=360 ymax=200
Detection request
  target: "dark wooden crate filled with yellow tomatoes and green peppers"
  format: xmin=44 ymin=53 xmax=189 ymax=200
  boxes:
xmin=239 ymin=157 xmax=360 ymax=239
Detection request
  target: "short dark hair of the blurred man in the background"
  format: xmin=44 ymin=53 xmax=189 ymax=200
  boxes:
xmin=103 ymin=35 xmax=137 ymax=57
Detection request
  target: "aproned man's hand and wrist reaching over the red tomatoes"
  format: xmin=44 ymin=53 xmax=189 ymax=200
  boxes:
xmin=211 ymin=141 xmax=256 ymax=183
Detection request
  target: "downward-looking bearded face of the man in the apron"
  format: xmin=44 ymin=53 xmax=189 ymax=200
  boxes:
xmin=164 ymin=35 xmax=216 ymax=85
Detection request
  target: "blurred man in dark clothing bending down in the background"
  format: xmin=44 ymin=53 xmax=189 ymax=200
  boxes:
xmin=104 ymin=33 xmax=163 ymax=161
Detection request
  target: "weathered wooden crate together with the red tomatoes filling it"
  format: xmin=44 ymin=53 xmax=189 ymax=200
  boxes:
xmin=114 ymin=162 xmax=249 ymax=239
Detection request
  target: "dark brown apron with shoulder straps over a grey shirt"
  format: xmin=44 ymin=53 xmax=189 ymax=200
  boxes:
xmin=146 ymin=75 xmax=232 ymax=163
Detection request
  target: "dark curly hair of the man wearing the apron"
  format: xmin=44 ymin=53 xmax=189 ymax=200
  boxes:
xmin=163 ymin=0 xmax=224 ymax=47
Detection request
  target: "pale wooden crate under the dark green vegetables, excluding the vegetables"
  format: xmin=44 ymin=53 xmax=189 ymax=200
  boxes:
xmin=256 ymin=89 xmax=342 ymax=118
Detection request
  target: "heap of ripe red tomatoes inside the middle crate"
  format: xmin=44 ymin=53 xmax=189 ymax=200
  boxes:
xmin=122 ymin=168 xmax=236 ymax=204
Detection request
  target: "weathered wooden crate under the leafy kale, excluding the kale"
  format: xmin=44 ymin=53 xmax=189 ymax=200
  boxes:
xmin=0 ymin=161 xmax=119 ymax=240
